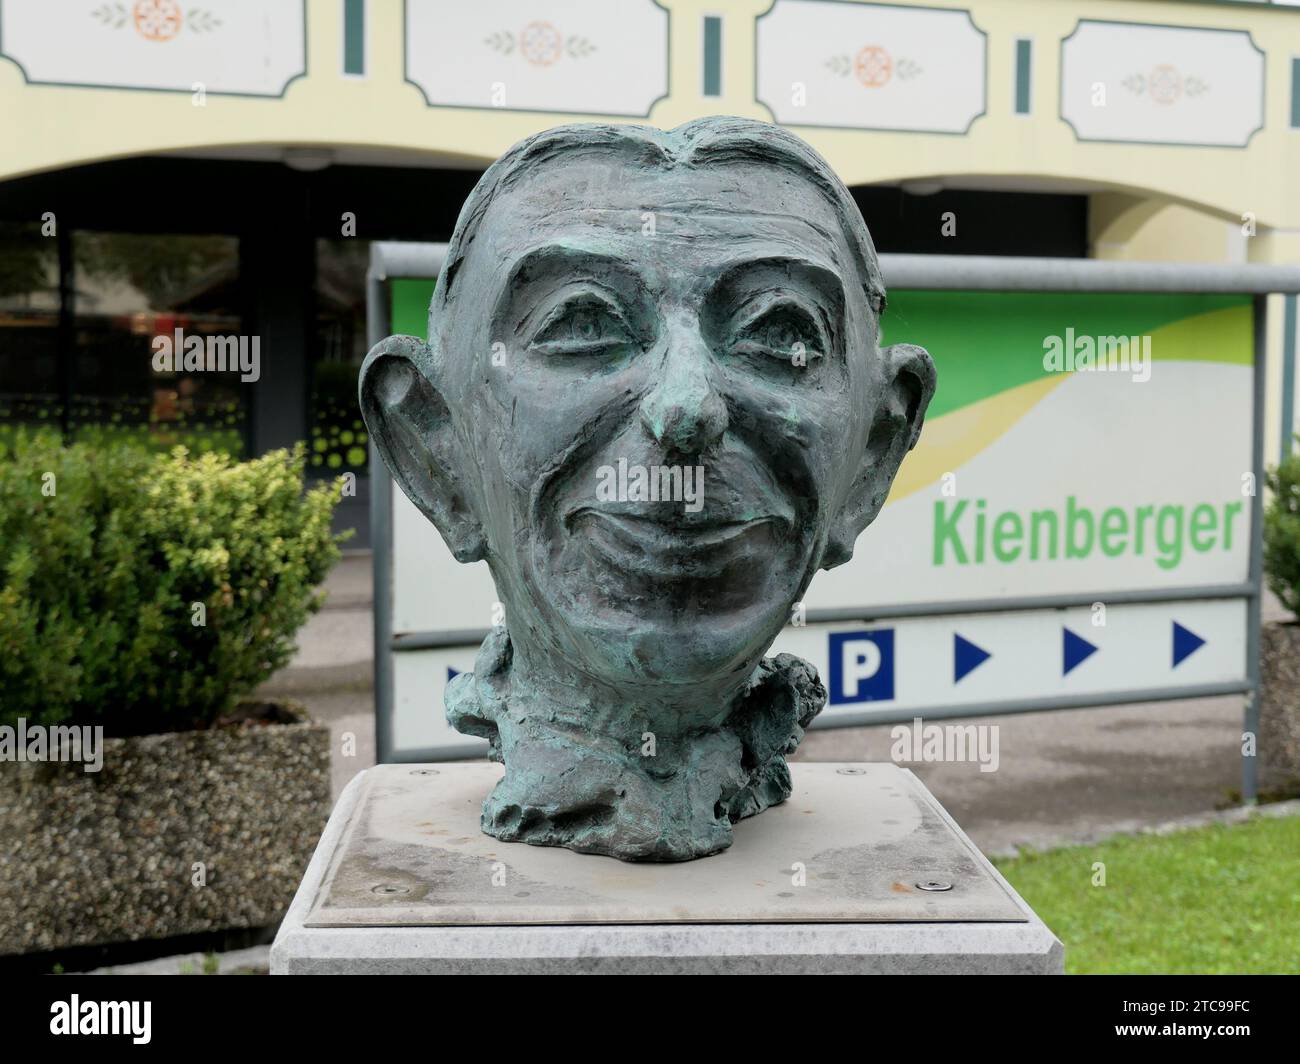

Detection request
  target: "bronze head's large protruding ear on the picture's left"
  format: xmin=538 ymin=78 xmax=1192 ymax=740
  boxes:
xmin=360 ymin=336 xmax=486 ymax=562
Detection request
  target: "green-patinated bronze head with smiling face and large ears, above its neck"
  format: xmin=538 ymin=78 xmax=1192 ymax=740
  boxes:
xmin=361 ymin=118 xmax=935 ymax=856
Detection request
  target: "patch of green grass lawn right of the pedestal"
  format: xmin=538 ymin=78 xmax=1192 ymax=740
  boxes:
xmin=995 ymin=817 xmax=1300 ymax=974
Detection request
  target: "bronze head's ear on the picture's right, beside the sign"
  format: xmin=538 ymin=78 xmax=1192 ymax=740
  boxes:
xmin=822 ymin=343 xmax=935 ymax=568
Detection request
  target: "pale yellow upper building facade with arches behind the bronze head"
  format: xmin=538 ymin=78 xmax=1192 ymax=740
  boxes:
xmin=0 ymin=0 xmax=1300 ymax=231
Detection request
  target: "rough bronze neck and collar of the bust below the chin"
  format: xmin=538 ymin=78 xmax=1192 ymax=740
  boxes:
xmin=446 ymin=631 xmax=826 ymax=861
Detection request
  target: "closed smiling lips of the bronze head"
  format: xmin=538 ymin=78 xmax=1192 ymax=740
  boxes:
xmin=568 ymin=506 xmax=788 ymax=576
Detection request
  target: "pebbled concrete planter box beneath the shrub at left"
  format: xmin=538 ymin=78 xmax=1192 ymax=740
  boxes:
xmin=0 ymin=704 xmax=330 ymax=955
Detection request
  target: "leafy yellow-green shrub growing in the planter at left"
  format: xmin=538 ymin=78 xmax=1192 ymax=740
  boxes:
xmin=0 ymin=434 xmax=342 ymax=735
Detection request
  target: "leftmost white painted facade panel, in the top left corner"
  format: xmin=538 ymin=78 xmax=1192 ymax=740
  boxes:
xmin=0 ymin=0 xmax=307 ymax=96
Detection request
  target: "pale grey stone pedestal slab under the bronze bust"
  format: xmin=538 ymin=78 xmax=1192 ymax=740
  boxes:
xmin=270 ymin=764 xmax=1063 ymax=974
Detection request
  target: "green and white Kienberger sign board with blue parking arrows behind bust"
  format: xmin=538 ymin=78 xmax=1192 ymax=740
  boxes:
xmin=379 ymin=278 xmax=1258 ymax=752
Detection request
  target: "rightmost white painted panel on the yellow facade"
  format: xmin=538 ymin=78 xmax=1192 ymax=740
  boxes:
xmin=1061 ymin=20 xmax=1264 ymax=147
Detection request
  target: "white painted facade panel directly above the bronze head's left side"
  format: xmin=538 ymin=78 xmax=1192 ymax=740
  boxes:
xmin=406 ymin=0 xmax=668 ymax=117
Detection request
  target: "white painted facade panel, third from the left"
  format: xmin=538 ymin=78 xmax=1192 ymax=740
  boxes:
xmin=754 ymin=0 xmax=987 ymax=133
